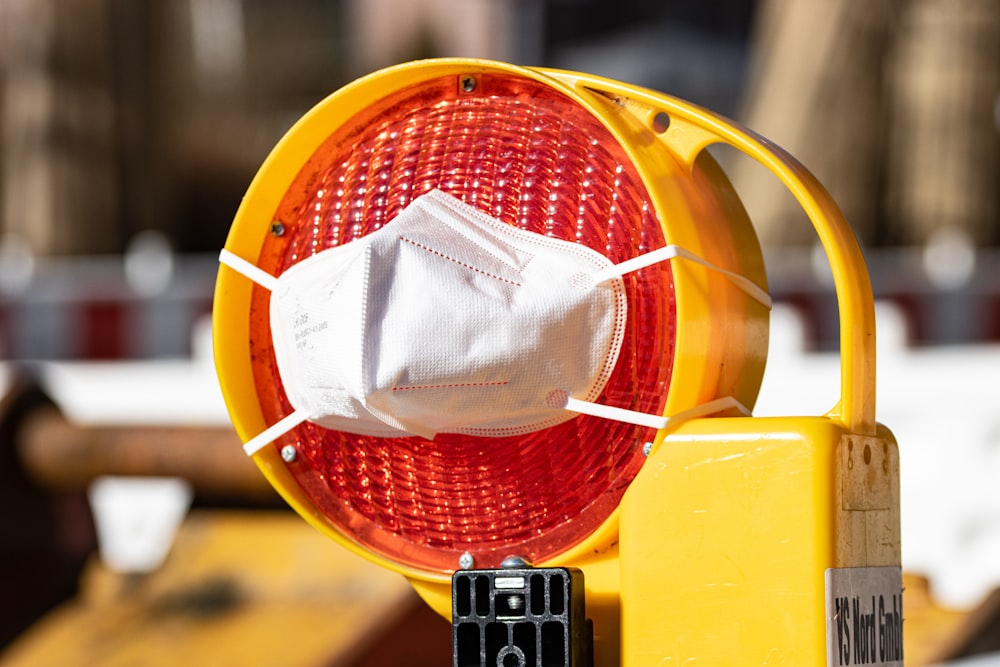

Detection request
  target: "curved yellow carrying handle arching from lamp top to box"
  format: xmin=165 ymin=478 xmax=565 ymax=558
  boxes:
xmin=541 ymin=69 xmax=875 ymax=435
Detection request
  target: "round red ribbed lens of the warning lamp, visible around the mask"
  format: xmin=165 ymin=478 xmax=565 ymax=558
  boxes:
xmin=250 ymin=74 xmax=675 ymax=572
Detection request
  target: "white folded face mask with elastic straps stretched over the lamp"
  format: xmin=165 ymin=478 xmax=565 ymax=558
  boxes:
xmin=220 ymin=190 xmax=769 ymax=454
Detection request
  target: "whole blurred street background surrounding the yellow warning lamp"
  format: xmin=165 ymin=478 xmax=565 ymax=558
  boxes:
xmin=0 ymin=0 xmax=1000 ymax=665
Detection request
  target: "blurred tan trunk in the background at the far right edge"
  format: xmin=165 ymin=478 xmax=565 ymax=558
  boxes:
xmin=886 ymin=0 xmax=1000 ymax=245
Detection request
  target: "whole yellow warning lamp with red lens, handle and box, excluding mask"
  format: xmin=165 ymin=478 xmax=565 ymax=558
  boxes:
xmin=213 ymin=59 xmax=899 ymax=665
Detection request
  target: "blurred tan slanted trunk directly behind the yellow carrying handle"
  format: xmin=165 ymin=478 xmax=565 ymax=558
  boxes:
xmin=734 ymin=0 xmax=903 ymax=244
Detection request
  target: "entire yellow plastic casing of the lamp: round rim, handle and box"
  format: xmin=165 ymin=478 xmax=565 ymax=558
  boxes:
xmin=214 ymin=59 xmax=899 ymax=666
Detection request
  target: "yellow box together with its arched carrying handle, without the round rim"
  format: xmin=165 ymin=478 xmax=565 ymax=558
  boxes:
xmin=548 ymin=72 xmax=900 ymax=666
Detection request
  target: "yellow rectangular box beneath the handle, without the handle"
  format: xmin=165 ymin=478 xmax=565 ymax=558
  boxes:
xmin=620 ymin=417 xmax=900 ymax=666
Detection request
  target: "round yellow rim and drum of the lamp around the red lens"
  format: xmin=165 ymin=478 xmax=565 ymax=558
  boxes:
xmin=213 ymin=59 xmax=768 ymax=584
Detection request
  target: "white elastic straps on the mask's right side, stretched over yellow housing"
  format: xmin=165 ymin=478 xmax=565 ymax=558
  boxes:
xmin=563 ymin=244 xmax=771 ymax=430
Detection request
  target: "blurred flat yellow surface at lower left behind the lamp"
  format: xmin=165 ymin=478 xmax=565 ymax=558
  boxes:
xmin=0 ymin=511 xmax=413 ymax=667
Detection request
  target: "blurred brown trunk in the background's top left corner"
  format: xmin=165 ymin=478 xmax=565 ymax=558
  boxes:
xmin=0 ymin=0 xmax=122 ymax=254
